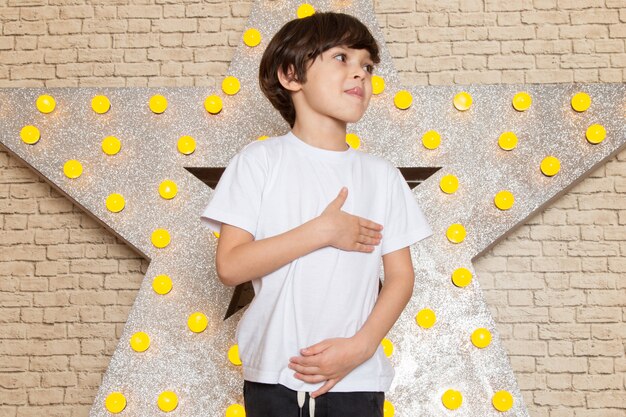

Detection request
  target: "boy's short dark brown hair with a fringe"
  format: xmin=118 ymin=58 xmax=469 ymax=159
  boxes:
xmin=259 ymin=12 xmax=380 ymax=127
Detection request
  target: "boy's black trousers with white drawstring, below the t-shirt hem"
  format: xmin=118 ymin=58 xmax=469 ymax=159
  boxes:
xmin=243 ymin=380 xmax=385 ymax=417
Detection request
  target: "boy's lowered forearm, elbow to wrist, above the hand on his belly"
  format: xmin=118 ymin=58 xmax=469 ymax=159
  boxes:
xmin=354 ymin=272 xmax=415 ymax=359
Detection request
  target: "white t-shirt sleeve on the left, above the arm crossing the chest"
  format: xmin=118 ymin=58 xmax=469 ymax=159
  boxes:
xmin=200 ymin=148 xmax=266 ymax=237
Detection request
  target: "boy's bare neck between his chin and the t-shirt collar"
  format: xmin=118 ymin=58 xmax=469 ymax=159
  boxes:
xmin=291 ymin=118 xmax=349 ymax=151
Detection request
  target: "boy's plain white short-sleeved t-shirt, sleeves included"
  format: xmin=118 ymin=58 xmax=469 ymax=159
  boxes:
xmin=201 ymin=132 xmax=432 ymax=392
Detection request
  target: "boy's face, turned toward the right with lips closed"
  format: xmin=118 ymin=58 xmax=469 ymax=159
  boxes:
xmin=292 ymin=46 xmax=374 ymax=123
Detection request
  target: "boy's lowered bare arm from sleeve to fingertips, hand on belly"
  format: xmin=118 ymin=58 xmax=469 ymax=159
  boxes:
xmin=289 ymin=247 xmax=415 ymax=398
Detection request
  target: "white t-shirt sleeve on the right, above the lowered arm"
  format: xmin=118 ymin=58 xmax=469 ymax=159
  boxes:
xmin=381 ymin=167 xmax=433 ymax=255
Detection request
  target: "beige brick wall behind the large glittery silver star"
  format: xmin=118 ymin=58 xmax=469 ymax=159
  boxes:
xmin=0 ymin=0 xmax=626 ymax=417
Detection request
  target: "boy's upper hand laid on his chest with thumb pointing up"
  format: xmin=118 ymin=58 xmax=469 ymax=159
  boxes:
xmin=319 ymin=187 xmax=383 ymax=252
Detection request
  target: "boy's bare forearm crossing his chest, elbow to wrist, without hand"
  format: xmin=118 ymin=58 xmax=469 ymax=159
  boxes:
xmin=221 ymin=217 xmax=328 ymax=286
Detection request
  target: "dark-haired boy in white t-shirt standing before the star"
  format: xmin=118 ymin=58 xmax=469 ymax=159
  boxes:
xmin=202 ymin=13 xmax=432 ymax=417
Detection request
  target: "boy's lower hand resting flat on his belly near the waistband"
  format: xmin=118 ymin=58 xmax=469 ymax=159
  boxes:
xmin=289 ymin=337 xmax=371 ymax=398
